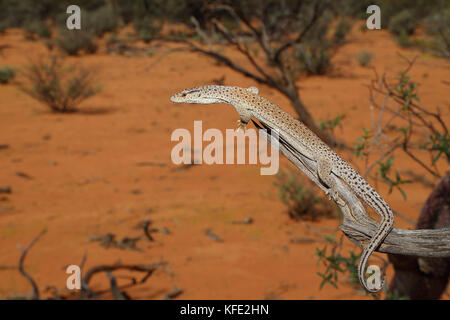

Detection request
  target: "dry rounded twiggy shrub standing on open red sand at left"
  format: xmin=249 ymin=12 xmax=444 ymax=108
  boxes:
xmin=19 ymin=56 xmax=100 ymax=112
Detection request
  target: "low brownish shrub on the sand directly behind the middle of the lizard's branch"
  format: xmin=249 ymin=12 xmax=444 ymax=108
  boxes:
xmin=275 ymin=171 xmax=335 ymax=220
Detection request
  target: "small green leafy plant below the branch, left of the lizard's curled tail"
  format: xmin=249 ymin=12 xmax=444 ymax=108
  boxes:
xmin=316 ymin=234 xmax=360 ymax=289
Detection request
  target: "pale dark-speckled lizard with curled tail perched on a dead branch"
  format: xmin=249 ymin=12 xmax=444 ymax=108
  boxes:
xmin=170 ymin=85 xmax=394 ymax=292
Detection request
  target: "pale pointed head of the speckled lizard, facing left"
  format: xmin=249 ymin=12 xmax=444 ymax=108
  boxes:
xmin=170 ymin=86 xmax=228 ymax=104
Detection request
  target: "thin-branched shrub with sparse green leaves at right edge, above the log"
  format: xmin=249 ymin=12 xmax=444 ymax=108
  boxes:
xmin=354 ymin=60 xmax=450 ymax=185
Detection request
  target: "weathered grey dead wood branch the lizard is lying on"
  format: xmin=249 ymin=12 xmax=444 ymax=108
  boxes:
xmin=252 ymin=120 xmax=450 ymax=258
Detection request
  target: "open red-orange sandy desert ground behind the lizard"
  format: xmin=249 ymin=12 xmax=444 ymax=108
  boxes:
xmin=0 ymin=25 xmax=450 ymax=299
